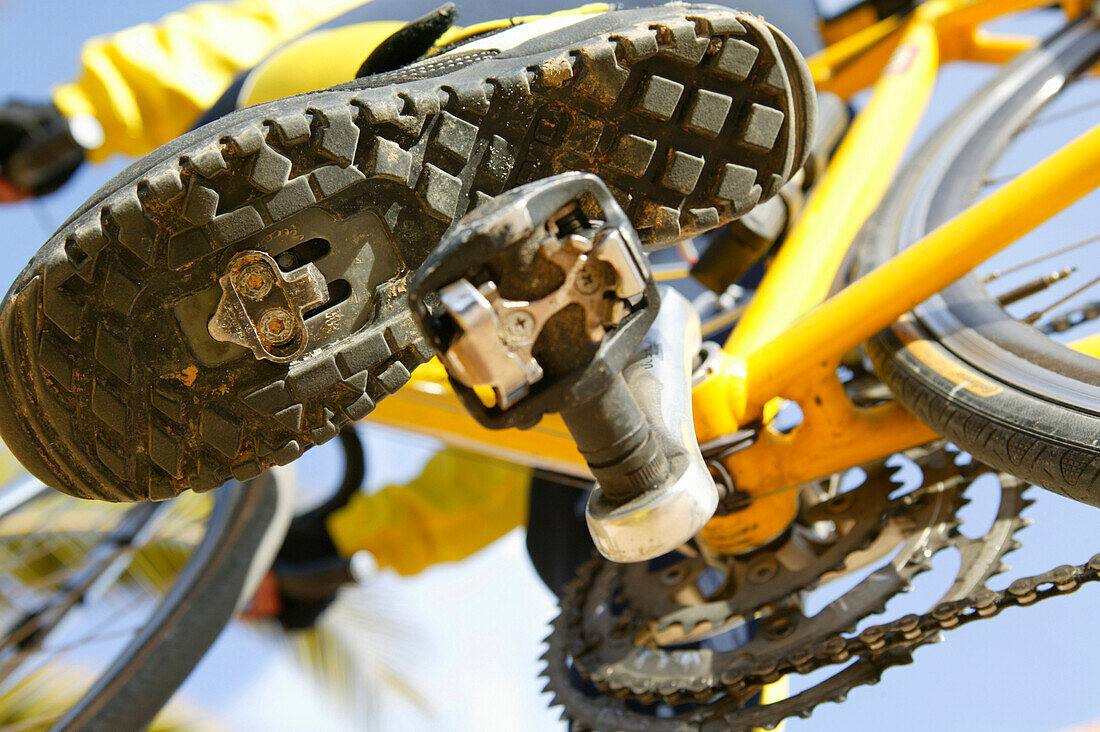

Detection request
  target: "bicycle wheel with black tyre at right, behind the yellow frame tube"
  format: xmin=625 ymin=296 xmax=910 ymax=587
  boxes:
xmin=855 ymin=13 xmax=1100 ymax=505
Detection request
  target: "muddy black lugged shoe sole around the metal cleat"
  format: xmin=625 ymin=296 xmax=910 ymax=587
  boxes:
xmin=0 ymin=6 xmax=813 ymax=501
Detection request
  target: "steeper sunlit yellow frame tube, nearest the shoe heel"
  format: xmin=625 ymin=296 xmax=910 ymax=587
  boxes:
xmin=725 ymin=13 xmax=938 ymax=357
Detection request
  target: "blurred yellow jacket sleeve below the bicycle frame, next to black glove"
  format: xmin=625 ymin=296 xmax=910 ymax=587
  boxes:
xmin=328 ymin=449 xmax=531 ymax=575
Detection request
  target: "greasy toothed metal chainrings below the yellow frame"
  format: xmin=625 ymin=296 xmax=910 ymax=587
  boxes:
xmin=543 ymin=443 xmax=1031 ymax=732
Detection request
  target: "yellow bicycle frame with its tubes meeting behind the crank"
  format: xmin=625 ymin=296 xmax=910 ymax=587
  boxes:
xmin=372 ymin=0 xmax=1100 ymax=551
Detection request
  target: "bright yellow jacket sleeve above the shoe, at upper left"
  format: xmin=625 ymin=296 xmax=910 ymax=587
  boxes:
xmin=53 ymin=0 xmax=365 ymax=161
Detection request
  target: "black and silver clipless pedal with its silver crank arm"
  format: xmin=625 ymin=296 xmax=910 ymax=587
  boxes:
xmin=409 ymin=173 xmax=717 ymax=561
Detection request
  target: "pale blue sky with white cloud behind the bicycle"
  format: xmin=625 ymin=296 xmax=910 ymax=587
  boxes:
xmin=0 ymin=0 xmax=1100 ymax=732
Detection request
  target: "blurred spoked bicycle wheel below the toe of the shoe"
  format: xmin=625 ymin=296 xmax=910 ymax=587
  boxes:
xmin=0 ymin=464 xmax=289 ymax=731
